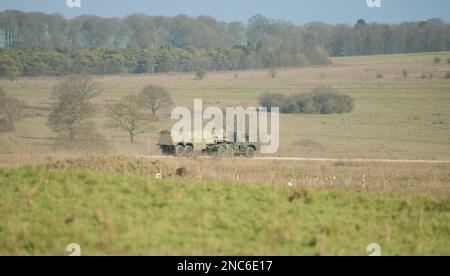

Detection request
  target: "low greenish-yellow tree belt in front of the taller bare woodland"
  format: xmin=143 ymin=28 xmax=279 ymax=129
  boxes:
xmin=0 ymin=46 xmax=330 ymax=77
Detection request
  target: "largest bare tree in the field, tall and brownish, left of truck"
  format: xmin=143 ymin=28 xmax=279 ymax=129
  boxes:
xmin=48 ymin=77 xmax=100 ymax=142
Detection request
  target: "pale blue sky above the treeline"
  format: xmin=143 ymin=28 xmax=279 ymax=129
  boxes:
xmin=0 ymin=0 xmax=450 ymax=24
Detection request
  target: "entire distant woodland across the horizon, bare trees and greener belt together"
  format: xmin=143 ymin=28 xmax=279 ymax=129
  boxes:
xmin=0 ymin=11 xmax=450 ymax=79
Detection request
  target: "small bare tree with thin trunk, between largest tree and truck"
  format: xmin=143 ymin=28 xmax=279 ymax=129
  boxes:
xmin=109 ymin=96 xmax=147 ymax=143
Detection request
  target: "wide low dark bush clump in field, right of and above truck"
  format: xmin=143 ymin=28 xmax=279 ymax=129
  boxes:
xmin=259 ymin=87 xmax=354 ymax=114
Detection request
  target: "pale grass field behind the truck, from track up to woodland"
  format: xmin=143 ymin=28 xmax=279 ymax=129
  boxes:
xmin=0 ymin=52 xmax=450 ymax=160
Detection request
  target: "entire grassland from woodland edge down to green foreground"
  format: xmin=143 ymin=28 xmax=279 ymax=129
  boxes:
xmin=0 ymin=52 xmax=450 ymax=255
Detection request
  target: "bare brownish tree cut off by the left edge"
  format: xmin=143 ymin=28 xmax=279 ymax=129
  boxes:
xmin=0 ymin=87 xmax=26 ymax=130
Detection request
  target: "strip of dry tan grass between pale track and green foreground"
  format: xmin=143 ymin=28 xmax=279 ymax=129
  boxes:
xmin=5 ymin=156 xmax=450 ymax=197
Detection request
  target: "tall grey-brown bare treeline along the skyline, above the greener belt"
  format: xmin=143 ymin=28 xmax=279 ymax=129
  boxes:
xmin=0 ymin=11 xmax=450 ymax=56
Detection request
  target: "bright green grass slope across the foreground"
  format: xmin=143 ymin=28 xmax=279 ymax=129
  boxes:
xmin=0 ymin=167 xmax=450 ymax=255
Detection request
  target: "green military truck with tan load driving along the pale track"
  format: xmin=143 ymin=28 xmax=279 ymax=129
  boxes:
xmin=158 ymin=130 xmax=257 ymax=157
